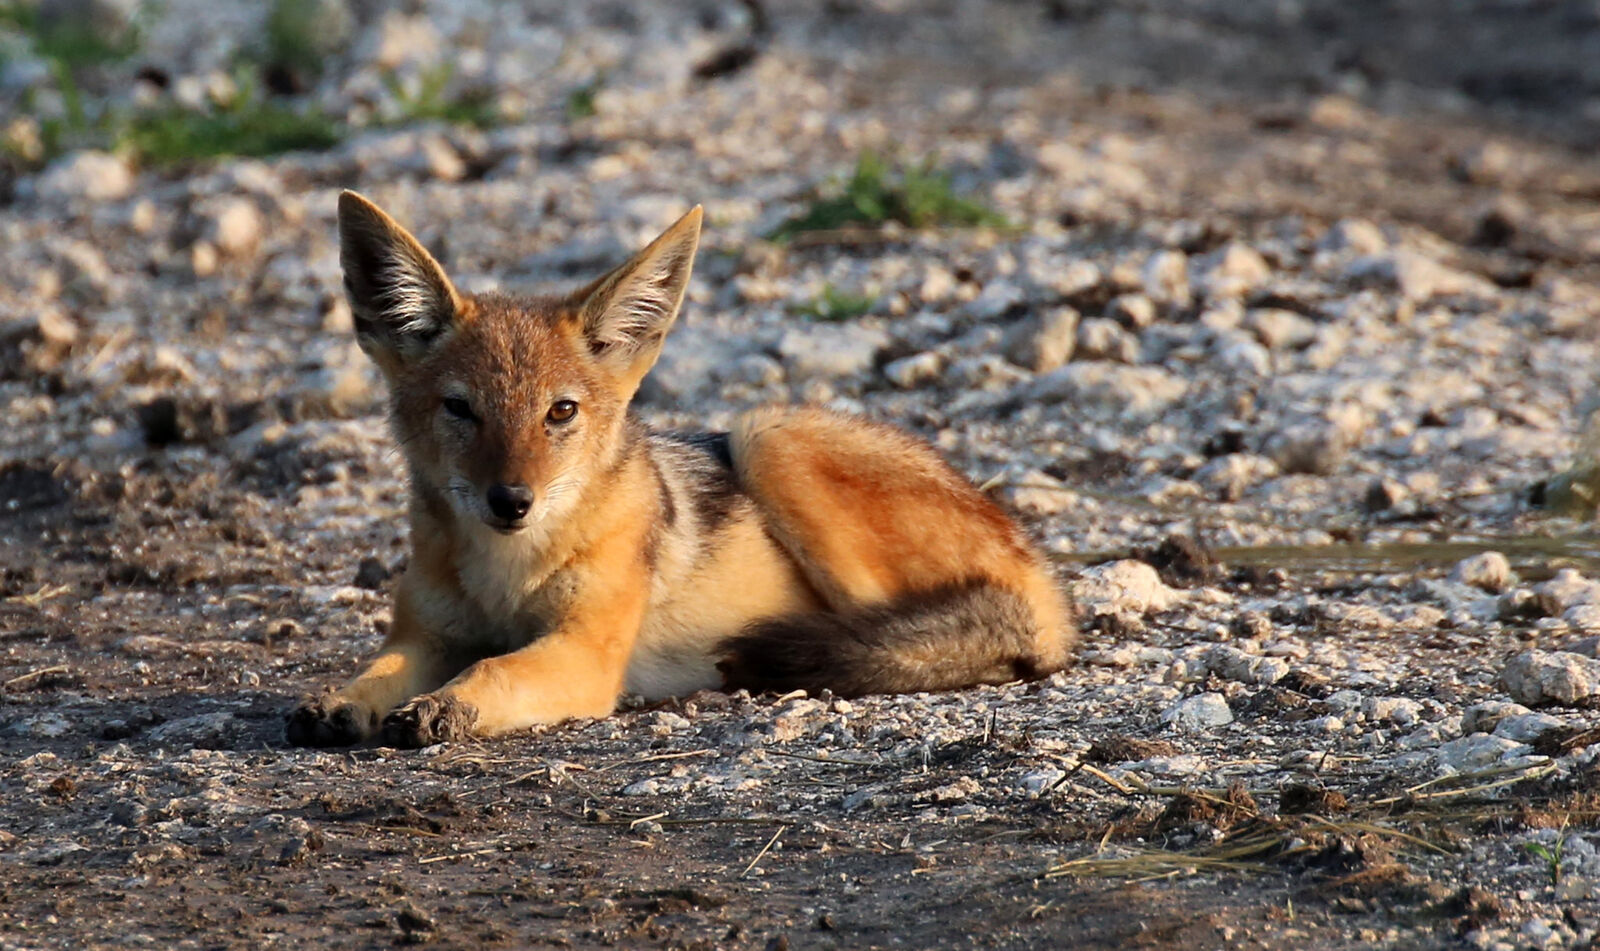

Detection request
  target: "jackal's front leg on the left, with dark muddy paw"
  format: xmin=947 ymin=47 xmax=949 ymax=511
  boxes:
xmin=285 ymin=581 xmax=459 ymax=746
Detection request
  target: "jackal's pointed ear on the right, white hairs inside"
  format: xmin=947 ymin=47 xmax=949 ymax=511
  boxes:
xmin=573 ymin=205 xmax=701 ymax=374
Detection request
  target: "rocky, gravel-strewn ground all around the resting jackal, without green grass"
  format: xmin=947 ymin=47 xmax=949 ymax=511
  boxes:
xmin=0 ymin=0 xmax=1600 ymax=949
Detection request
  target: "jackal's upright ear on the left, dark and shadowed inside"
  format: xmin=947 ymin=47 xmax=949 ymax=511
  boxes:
xmin=339 ymin=192 xmax=461 ymax=357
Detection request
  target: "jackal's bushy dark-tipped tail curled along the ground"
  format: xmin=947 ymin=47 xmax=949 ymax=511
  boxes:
xmin=718 ymin=583 xmax=1067 ymax=696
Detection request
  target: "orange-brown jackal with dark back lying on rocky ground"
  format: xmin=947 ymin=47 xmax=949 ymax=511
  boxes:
xmin=288 ymin=192 xmax=1072 ymax=744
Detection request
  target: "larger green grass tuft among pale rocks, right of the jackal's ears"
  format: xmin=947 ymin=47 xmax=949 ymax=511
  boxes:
xmin=770 ymin=152 xmax=1006 ymax=242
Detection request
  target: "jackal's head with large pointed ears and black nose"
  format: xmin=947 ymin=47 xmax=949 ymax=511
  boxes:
xmin=339 ymin=192 xmax=701 ymax=533
